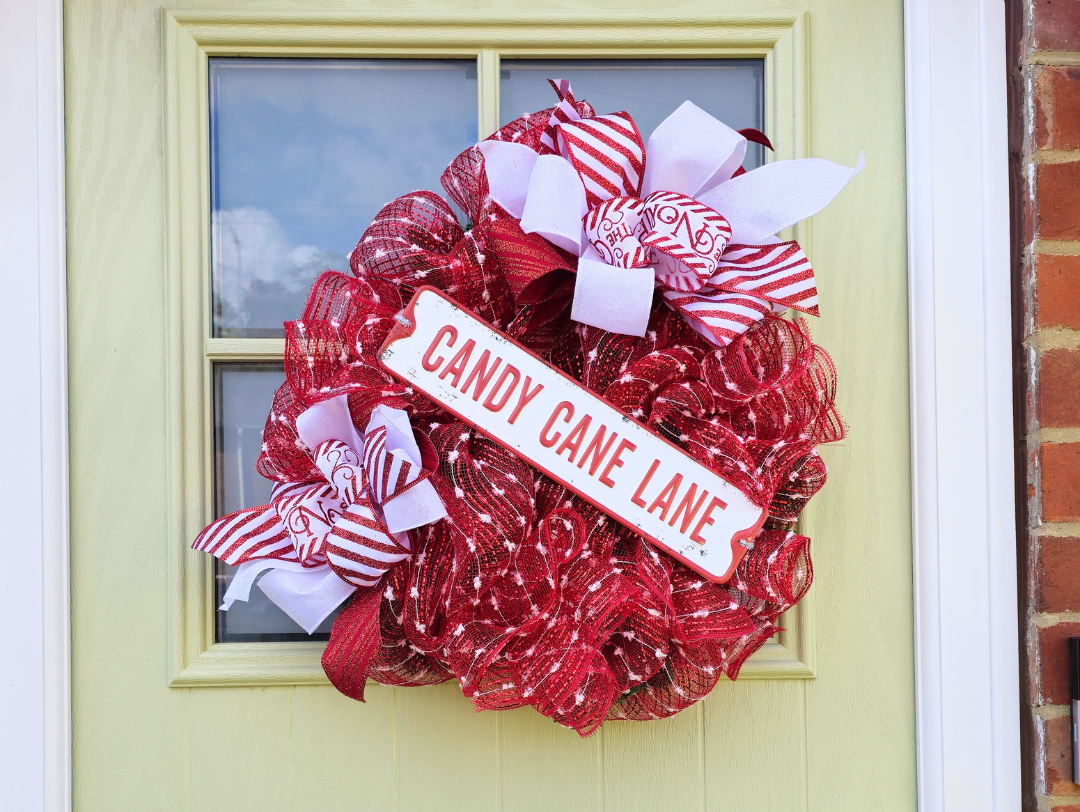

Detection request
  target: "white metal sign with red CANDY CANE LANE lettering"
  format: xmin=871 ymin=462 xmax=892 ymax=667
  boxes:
xmin=380 ymin=287 xmax=766 ymax=583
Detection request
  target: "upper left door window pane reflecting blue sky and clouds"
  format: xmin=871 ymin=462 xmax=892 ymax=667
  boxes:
xmin=210 ymin=58 xmax=477 ymax=338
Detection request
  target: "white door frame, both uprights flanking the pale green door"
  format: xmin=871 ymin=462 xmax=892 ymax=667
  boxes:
xmin=0 ymin=0 xmax=1021 ymax=812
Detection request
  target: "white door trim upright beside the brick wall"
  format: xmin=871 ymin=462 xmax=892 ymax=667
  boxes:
xmin=904 ymin=0 xmax=1021 ymax=812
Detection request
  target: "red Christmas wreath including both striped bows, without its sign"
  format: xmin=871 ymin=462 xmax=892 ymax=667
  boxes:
xmin=193 ymin=82 xmax=862 ymax=735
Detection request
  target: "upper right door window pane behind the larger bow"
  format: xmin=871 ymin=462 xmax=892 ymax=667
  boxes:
xmin=499 ymin=59 xmax=765 ymax=170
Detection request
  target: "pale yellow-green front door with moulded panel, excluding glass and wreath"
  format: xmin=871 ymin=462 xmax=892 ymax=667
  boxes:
xmin=65 ymin=0 xmax=915 ymax=812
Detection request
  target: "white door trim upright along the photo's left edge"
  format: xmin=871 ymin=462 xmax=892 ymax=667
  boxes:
xmin=0 ymin=0 xmax=71 ymax=812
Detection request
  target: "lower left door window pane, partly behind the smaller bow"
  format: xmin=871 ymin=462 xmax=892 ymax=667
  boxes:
xmin=214 ymin=364 xmax=336 ymax=642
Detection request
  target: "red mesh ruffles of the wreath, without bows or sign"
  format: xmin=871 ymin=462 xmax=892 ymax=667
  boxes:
xmin=245 ymin=95 xmax=843 ymax=735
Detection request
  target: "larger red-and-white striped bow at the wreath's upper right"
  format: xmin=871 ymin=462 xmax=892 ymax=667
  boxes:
xmin=477 ymin=80 xmax=864 ymax=346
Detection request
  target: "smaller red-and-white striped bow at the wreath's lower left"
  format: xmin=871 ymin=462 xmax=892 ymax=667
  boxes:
xmin=192 ymin=395 xmax=446 ymax=634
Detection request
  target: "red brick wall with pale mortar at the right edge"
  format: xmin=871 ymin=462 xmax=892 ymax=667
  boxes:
xmin=1008 ymin=0 xmax=1080 ymax=812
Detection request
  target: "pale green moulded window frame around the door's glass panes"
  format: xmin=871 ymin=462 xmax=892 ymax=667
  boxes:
xmin=162 ymin=10 xmax=821 ymax=688
